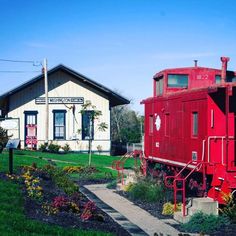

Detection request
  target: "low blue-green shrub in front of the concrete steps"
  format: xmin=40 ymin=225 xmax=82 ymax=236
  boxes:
xmin=181 ymin=212 xmax=229 ymax=234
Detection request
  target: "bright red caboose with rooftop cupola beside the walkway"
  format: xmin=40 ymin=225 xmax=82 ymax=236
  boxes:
xmin=141 ymin=57 xmax=236 ymax=203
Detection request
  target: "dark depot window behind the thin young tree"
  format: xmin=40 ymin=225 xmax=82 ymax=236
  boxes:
xmin=82 ymin=111 xmax=94 ymax=140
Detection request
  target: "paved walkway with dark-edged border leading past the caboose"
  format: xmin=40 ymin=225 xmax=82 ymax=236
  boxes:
xmin=81 ymin=184 xmax=180 ymax=236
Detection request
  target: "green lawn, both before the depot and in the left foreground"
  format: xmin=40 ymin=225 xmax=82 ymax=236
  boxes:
xmin=0 ymin=150 xmax=137 ymax=236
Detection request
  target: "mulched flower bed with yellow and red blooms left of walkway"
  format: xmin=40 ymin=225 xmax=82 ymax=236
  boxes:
xmin=7 ymin=166 xmax=129 ymax=235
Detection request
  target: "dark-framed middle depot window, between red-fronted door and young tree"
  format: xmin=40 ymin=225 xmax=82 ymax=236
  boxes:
xmin=53 ymin=110 xmax=66 ymax=140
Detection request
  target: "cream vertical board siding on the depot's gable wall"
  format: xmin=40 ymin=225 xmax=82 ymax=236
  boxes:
xmin=8 ymin=71 xmax=110 ymax=151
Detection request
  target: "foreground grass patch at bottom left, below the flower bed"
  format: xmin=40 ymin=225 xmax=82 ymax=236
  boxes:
xmin=0 ymin=181 xmax=111 ymax=236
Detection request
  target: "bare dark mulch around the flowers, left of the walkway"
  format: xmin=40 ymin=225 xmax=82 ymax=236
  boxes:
xmin=0 ymin=173 xmax=130 ymax=236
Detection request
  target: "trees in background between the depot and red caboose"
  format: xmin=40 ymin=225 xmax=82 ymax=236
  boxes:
xmin=111 ymin=106 xmax=143 ymax=143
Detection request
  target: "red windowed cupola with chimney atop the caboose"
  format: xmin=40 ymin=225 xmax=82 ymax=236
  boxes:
xmin=153 ymin=57 xmax=236 ymax=97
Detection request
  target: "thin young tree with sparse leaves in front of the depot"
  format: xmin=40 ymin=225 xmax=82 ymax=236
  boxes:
xmin=78 ymin=101 xmax=108 ymax=166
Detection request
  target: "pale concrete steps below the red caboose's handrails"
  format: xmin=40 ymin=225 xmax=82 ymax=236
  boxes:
xmin=174 ymin=197 xmax=218 ymax=223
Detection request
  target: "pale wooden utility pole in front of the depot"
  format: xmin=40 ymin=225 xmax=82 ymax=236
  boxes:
xmin=43 ymin=58 xmax=49 ymax=144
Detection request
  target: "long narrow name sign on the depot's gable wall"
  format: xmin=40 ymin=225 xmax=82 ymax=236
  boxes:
xmin=35 ymin=97 xmax=84 ymax=104
